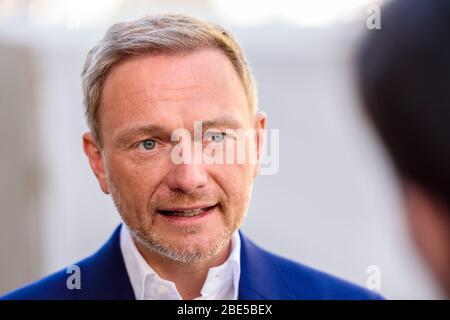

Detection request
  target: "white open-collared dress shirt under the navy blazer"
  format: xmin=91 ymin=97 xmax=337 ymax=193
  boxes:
xmin=120 ymin=223 xmax=241 ymax=300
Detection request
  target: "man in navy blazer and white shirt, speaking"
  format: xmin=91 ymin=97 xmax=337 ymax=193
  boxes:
xmin=1 ymin=15 xmax=379 ymax=300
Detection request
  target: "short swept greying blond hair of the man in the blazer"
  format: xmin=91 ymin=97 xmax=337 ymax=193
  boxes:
xmin=81 ymin=15 xmax=257 ymax=147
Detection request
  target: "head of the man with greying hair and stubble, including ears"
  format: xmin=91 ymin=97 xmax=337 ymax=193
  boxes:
xmin=82 ymin=15 xmax=265 ymax=263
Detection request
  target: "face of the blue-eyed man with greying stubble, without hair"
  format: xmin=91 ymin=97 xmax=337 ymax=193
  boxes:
xmin=84 ymin=49 xmax=265 ymax=262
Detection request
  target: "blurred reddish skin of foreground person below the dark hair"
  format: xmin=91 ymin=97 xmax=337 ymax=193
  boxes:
xmin=403 ymin=181 xmax=450 ymax=297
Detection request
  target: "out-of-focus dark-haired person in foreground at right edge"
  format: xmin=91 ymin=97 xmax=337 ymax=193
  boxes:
xmin=359 ymin=0 xmax=450 ymax=297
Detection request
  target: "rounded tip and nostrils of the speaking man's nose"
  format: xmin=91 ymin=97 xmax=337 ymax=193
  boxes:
xmin=167 ymin=163 xmax=208 ymax=193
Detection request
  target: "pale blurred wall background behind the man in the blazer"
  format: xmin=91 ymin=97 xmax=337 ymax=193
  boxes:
xmin=0 ymin=0 xmax=440 ymax=299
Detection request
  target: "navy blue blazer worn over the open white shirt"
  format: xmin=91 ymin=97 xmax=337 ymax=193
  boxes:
xmin=0 ymin=226 xmax=382 ymax=300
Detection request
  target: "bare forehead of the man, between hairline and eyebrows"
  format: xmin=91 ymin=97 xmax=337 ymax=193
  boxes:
xmin=100 ymin=49 xmax=250 ymax=138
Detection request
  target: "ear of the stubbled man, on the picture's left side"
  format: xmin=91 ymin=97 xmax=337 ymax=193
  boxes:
xmin=83 ymin=132 xmax=109 ymax=194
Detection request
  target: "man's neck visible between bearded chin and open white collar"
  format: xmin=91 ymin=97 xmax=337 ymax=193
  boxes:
xmin=134 ymin=239 xmax=231 ymax=300
